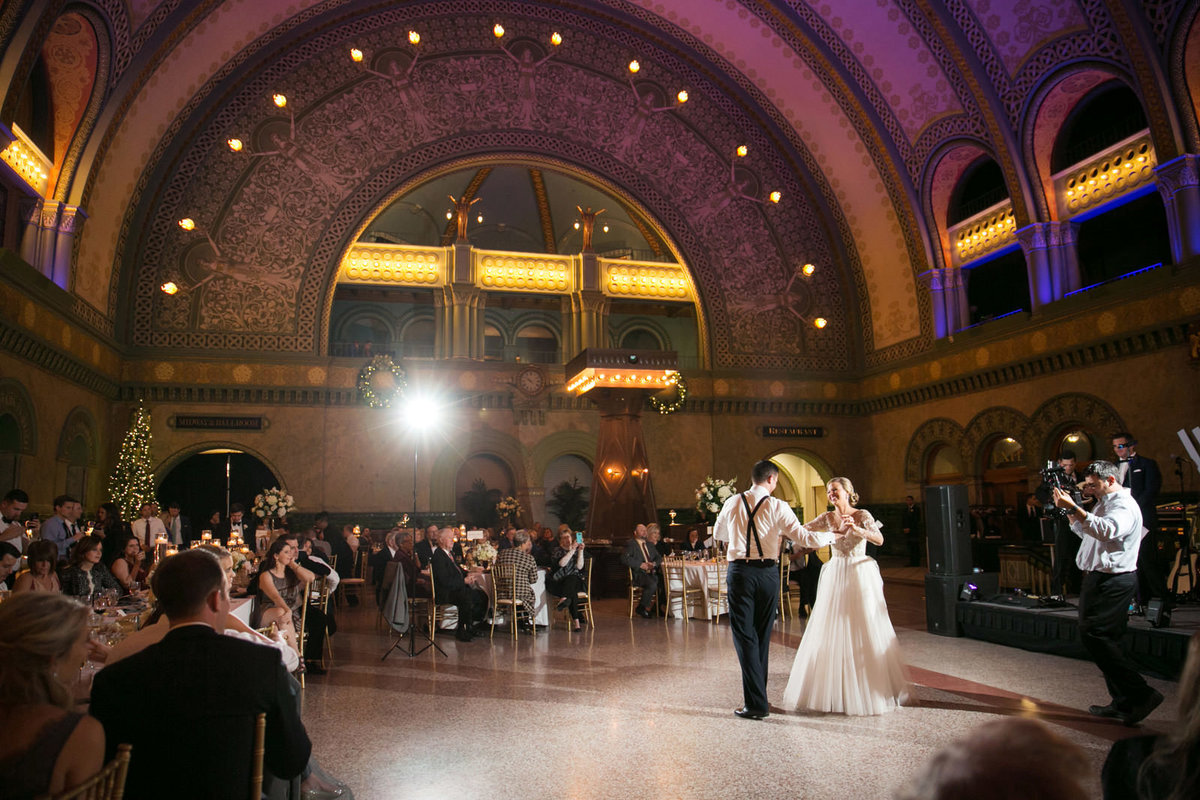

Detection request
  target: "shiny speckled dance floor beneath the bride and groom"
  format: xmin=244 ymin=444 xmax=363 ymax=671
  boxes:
xmin=304 ymin=582 xmax=1177 ymax=800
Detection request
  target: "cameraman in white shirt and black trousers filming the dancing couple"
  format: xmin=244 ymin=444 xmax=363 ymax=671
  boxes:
xmin=1054 ymin=461 xmax=1163 ymax=726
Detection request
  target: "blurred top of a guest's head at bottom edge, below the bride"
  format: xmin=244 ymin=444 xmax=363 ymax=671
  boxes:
xmin=895 ymin=718 xmax=1088 ymax=800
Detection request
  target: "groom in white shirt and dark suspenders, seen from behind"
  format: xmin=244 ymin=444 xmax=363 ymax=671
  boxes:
xmin=714 ymin=461 xmax=835 ymax=720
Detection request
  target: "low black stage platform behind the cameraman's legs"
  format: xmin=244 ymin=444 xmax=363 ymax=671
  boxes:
xmin=955 ymin=596 xmax=1200 ymax=680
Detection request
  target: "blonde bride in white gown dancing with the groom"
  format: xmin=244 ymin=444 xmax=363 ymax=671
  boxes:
xmin=784 ymin=477 xmax=908 ymax=715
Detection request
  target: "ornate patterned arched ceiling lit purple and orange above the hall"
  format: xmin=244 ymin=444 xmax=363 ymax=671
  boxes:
xmin=0 ymin=0 xmax=1194 ymax=372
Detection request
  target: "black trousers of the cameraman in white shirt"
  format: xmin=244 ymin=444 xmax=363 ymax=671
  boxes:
xmin=1079 ymin=572 xmax=1153 ymax=711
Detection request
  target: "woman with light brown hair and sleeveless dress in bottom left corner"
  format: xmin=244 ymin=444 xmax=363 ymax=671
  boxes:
xmin=0 ymin=592 xmax=104 ymax=798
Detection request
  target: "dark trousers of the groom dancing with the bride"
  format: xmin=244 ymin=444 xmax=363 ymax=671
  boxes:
xmin=725 ymin=561 xmax=779 ymax=711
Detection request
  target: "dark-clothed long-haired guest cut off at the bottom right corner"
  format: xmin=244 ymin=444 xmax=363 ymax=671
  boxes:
xmin=1100 ymin=633 xmax=1200 ymax=800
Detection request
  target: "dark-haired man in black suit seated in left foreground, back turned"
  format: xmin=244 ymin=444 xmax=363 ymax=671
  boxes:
xmin=91 ymin=548 xmax=312 ymax=800
